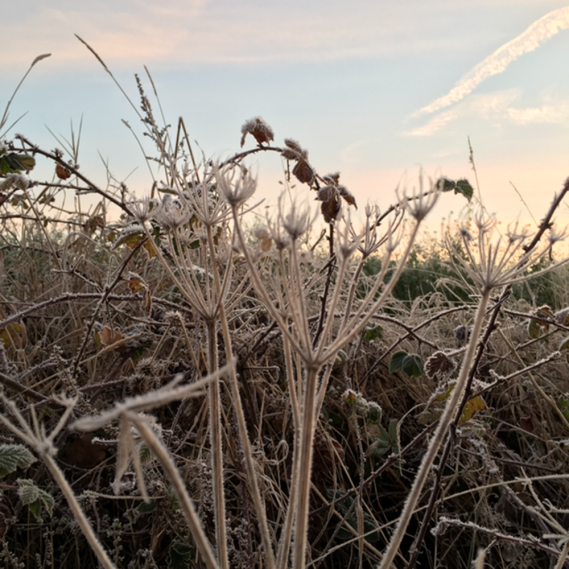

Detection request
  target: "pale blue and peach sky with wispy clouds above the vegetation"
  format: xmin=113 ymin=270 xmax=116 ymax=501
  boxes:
xmin=0 ymin=0 xmax=569 ymax=230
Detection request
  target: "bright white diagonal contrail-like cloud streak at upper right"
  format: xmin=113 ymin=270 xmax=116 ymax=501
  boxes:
xmin=414 ymin=6 xmax=569 ymax=116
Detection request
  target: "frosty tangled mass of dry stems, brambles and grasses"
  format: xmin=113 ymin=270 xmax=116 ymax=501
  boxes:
xmin=0 ymin=44 xmax=569 ymax=569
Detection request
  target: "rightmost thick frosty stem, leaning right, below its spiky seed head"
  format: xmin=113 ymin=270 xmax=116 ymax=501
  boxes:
xmin=379 ymin=287 xmax=492 ymax=569
